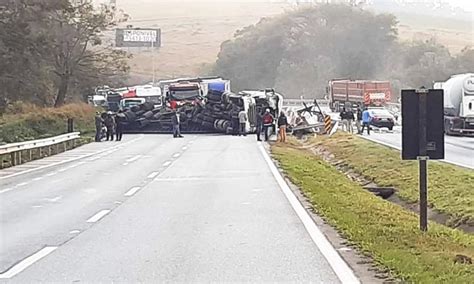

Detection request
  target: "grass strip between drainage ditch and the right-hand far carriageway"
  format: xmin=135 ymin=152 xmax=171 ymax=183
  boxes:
xmin=311 ymin=133 xmax=474 ymax=225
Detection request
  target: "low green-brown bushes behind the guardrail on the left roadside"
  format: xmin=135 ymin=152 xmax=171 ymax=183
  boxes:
xmin=0 ymin=102 xmax=95 ymax=144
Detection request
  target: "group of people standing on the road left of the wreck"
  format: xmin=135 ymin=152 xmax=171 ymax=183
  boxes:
xmin=95 ymin=111 xmax=124 ymax=142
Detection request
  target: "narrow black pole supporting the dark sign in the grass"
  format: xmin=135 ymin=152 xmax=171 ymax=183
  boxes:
xmin=418 ymin=89 xmax=428 ymax=231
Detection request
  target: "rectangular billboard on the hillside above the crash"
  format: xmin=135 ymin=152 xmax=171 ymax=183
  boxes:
xmin=115 ymin=29 xmax=161 ymax=47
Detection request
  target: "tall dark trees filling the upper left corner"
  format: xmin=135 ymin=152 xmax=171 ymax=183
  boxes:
xmin=0 ymin=0 xmax=129 ymax=107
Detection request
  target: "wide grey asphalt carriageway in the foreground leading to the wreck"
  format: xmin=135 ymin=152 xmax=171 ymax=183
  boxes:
xmin=0 ymin=135 xmax=357 ymax=283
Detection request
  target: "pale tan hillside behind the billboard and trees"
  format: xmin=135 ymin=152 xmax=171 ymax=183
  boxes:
xmin=113 ymin=0 xmax=472 ymax=82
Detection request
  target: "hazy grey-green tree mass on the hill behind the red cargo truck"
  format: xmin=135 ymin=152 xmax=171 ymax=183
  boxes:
xmin=213 ymin=4 xmax=474 ymax=98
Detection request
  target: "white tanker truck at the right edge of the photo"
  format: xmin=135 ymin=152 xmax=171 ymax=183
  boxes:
xmin=434 ymin=73 xmax=474 ymax=136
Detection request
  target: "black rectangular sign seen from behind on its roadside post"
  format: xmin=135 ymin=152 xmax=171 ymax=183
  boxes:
xmin=402 ymin=89 xmax=444 ymax=231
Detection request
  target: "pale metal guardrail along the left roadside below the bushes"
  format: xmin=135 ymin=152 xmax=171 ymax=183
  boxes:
xmin=0 ymin=132 xmax=81 ymax=168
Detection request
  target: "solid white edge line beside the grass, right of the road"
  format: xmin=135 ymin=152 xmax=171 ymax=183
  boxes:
xmin=258 ymin=144 xmax=360 ymax=284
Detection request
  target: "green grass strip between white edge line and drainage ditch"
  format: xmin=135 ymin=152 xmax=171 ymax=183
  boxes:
xmin=272 ymin=145 xmax=474 ymax=283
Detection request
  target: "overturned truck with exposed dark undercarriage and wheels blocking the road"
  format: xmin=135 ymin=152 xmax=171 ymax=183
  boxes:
xmin=117 ymin=88 xmax=283 ymax=134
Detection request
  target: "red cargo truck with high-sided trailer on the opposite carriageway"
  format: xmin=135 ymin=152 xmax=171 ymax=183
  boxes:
xmin=326 ymin=79 xmax=392 ymax=112
